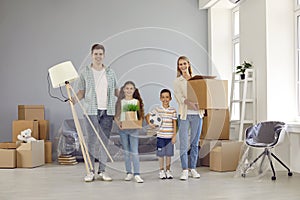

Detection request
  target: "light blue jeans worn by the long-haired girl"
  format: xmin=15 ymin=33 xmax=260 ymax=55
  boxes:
xmin=119 ymin=129 xmax=140 ymax=175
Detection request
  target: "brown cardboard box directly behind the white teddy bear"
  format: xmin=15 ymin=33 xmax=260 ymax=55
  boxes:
xmin=12 ymin=120 xmax=40 ymax=142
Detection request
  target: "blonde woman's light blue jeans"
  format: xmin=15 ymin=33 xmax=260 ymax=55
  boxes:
xmin=178 ymin=115 xmax=202 ymax=169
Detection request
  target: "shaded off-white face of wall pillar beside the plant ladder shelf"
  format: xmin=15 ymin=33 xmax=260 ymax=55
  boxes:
xmin=240 ymin=0 xmax=267 ymax=121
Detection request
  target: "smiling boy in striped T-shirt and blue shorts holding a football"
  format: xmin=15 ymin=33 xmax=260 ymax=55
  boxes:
xmin=146 ymin=89 xmax=177 ymax=179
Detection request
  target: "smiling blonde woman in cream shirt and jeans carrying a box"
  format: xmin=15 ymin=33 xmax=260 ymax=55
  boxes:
xmin=174 ymin=56 xmax=204 ymax=180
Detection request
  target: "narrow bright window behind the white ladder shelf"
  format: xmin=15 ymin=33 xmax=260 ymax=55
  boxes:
xmin=231 ymin=8 xmax=240 ymax=120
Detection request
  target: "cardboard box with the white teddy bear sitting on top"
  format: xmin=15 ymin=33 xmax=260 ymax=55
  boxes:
xmin=17 ymin=140 xmax=45 ymax=168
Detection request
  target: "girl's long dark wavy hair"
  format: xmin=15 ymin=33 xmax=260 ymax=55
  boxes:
xmin=116 ymin=81 xmax=144 ymax=119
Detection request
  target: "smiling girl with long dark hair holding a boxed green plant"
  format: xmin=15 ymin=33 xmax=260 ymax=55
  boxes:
xmin=115 ymin=81 xmax=144 ymax=183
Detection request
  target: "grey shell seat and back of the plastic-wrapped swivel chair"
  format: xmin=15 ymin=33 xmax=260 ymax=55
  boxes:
xmin=245 ymin=121 xmax=286 ymax=147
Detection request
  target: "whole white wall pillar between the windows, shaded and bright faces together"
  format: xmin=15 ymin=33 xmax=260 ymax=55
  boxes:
xmin=240 ymin=0 xmax=296 ymax=121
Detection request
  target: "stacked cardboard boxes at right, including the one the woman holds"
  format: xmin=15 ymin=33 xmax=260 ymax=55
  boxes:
xmin=187 ymin=79 xmax=240 ymax=171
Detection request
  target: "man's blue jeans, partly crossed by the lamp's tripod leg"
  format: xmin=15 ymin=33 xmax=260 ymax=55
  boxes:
xmin=85 ymin=110 xmax=114 ymax=172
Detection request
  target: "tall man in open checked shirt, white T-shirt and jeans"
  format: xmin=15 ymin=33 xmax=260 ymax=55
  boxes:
xmin=72 ymin=44 xmax=119 ymax=181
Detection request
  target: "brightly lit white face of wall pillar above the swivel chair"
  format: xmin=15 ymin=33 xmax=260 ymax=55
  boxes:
xmin=266 ymin=0 xmax=297 ymax=121
